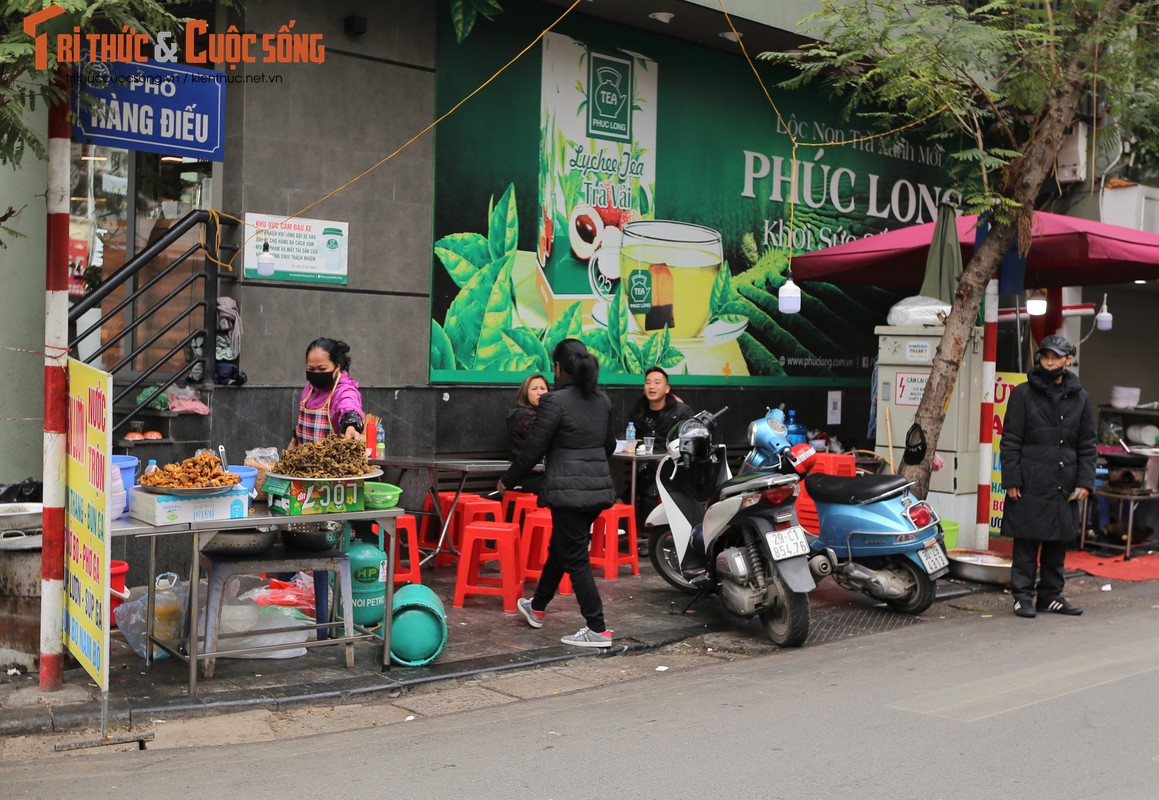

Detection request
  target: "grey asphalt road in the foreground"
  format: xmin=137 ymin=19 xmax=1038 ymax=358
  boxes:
xmin=0 ymin=572 xmax=1159 ymax=800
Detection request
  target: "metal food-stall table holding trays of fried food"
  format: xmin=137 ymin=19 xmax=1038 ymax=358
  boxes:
xmin=110 ymin=504 xmax=402 ymax=697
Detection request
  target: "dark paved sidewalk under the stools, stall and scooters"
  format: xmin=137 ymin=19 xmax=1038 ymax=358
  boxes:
xmin=0 ymin=560 xmax=1007 ymax=736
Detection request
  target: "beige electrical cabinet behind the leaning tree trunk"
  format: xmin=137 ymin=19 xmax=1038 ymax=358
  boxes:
xmin=874 ymin=326 xmax=982 ymax=491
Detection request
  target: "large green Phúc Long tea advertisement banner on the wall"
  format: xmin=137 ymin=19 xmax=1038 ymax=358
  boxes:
xmin=430 ymin=0 xmax=956 ymax=386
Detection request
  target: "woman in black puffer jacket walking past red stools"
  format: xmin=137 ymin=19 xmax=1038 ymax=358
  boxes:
xmin=498 ymin=339 xmax=615 ymax=647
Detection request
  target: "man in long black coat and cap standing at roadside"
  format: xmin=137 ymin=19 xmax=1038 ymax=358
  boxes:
xmin=1000 ymin=335 xmax=1095 ymax=618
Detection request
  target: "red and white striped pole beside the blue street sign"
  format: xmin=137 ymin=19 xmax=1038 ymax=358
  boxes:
xmin=41 ymin=71 xmax=72 ymax=690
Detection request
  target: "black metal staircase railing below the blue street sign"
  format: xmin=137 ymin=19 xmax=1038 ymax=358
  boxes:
xmin=68 ymin=210 xmax=234 ymax=429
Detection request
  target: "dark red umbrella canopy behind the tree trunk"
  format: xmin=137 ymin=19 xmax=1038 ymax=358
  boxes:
xmin=793 ymin=211 xmax=1159 ymax=292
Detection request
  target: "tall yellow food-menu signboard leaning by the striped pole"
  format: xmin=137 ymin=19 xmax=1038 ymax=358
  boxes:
xmin=65 ymin=358 xmax=112 ymax=691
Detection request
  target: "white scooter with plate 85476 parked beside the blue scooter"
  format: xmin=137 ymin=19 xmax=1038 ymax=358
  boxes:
xmin=646 ymin=407 xmax=816 ymax=647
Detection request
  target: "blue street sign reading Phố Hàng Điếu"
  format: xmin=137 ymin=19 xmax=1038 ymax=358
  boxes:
xmin=73 ymin=61 xmax=225 ymax=161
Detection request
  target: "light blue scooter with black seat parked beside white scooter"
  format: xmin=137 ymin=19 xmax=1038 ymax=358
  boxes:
xmin=742 ymin=408 xmax=949 ymax=614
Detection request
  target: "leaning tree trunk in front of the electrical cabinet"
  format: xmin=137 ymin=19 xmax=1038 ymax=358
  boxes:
xmin=902 ymin=0 xmax=1123 ymax=497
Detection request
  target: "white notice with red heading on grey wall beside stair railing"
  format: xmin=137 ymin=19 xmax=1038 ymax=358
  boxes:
xmin=242 ymin=213 xmax=350 ymax=283
